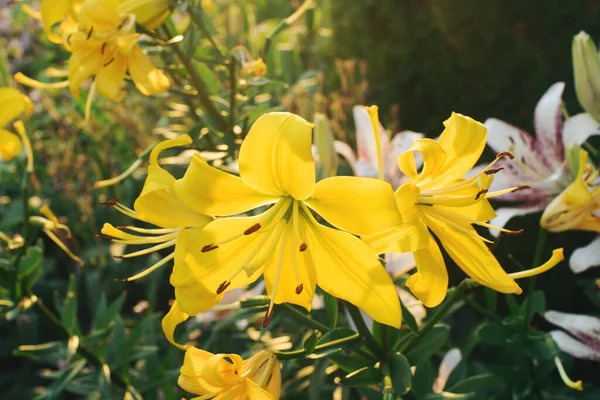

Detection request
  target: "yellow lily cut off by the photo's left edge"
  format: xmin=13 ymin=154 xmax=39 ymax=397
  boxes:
xmin=0 ymin=88 xmax=33 ymax=164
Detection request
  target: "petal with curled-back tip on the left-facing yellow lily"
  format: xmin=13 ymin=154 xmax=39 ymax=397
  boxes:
xmin=133 ymin=135 xmax=212 ymax=228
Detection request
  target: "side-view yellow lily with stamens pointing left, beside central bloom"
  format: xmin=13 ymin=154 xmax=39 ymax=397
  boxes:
xmin=101 ymin=135 xmax=212 ymax=282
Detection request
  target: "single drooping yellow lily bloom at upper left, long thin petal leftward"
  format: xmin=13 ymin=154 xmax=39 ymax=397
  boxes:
xmin=15 ymin=0 xmax=170 ymax=101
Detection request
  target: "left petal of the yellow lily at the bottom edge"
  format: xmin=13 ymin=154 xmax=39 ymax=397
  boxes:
xmin=177 ymin=346 xmax=221 ymax=395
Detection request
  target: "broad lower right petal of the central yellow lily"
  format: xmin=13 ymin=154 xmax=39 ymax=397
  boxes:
xmin=306 ymin=211 xmax=402 ymax=328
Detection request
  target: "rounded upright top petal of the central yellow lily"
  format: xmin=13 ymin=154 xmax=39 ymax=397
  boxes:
xmin=239 ymin=112 xmax=315 ymax=200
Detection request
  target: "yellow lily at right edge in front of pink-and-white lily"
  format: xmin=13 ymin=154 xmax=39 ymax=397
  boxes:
xmin=540 ymin=150 xmax=600 ymax=232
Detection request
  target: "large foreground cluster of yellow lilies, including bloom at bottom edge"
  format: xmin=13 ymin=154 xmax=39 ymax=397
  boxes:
xmin=102 ymin=108 xmax=563 ymax=398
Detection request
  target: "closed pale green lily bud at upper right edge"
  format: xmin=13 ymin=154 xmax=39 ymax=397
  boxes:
xmin=573 ymin=31 xmax=600 ymax=121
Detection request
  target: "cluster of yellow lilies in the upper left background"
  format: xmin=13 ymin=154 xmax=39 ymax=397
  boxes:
xmin=15 ymin=0 xmax=170 ymax=101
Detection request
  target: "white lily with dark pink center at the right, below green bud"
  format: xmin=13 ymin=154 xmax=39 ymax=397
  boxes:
xmin=485 ymin=82 xmax=600 ymax=234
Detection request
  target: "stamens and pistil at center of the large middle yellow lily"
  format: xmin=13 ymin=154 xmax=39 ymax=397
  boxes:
xmin=201 ymin=196 xmax=308 ymax=327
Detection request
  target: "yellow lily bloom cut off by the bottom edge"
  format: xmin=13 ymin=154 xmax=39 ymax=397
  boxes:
xmin=177 ymin=346 xmax=281 ymax=400
